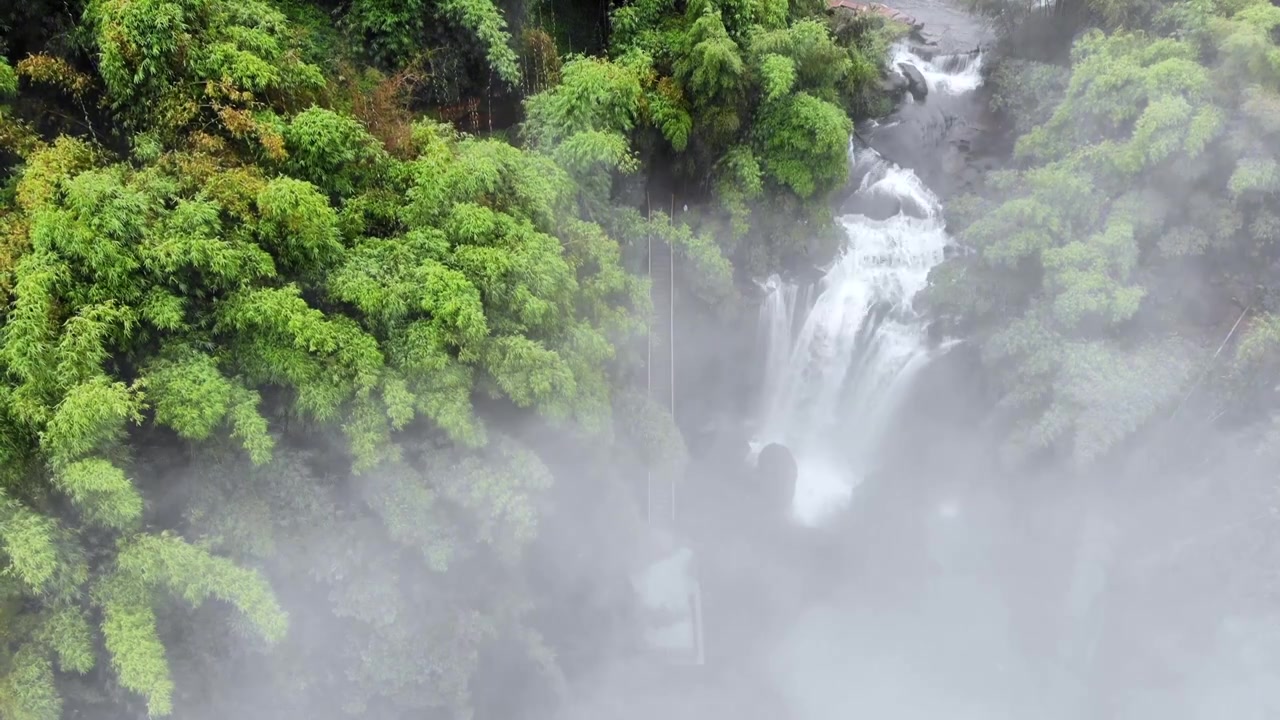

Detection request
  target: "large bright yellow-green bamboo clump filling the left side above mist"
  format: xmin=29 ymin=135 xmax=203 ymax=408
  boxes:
xmin=0 ymin=102 xmax=634 ymax=716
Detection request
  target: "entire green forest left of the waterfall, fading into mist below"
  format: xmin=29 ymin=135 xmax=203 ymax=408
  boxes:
xmin=0 ymin=0 xmax=893 ymax=720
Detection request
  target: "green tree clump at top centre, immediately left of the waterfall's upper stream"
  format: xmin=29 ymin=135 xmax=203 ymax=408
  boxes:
xmin=555 ymin=0 xmax=900 ymax=273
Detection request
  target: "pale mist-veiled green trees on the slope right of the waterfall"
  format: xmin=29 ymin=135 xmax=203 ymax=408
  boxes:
xmin=931 ymin=3 xmax=1280 ymax=464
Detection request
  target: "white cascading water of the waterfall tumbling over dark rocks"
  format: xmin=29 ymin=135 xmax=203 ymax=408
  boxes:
xmin=755 ymin=46 xmax=982 ymax=524
